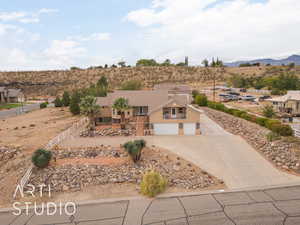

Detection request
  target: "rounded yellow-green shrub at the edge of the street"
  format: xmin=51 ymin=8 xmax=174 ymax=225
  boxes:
xmin=141 ymin=170 xmax=168 ymax=197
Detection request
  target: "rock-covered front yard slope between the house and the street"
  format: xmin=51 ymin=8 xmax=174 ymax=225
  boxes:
xmin=29 ymin=147 xmax=223 ymax=192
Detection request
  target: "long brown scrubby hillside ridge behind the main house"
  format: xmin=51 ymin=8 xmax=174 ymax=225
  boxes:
xmin=0 ymin=66 xmax=300 ymax=96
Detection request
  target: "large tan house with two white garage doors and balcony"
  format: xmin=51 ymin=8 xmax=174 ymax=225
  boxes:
xmin=96 ymin=90 xmax=200 ymax=136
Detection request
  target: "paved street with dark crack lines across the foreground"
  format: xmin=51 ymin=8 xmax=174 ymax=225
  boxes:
xmin=0 ymin=186 xmax=300 ymax=225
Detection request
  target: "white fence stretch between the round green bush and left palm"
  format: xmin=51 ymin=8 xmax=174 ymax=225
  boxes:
xmin=45 ymin=118 xmax=89 ymax=150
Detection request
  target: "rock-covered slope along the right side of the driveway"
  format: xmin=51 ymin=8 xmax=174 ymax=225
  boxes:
xmin=203 ymin=108 xmax=300 ymax=173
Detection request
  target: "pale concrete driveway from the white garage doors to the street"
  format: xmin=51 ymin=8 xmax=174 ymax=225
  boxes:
xmin=64 ymin=114 xmax=300 ymax=188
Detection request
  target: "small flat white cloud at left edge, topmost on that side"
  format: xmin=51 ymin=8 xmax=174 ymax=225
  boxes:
xmin=0 ymin=8 xmax=58 ymax=23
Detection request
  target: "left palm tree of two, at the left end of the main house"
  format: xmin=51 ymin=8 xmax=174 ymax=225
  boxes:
xmin=80 ymin=96 xmax=100 ymax=130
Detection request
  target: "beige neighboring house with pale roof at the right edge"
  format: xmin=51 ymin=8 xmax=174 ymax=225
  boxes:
xmin=266 ymin=91 xmax=300 ymax=116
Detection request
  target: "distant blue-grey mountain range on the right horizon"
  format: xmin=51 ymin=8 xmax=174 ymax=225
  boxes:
xmin=225 ymin=55 xmax=300 ymax=67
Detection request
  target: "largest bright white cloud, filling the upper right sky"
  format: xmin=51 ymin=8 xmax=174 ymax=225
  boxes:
xmin=125 ymin=0 xmax=300 ymax=64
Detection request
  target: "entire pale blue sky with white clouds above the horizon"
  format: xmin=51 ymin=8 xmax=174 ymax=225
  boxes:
xmin=0 ymin=0 xmax=300 ymax=70
